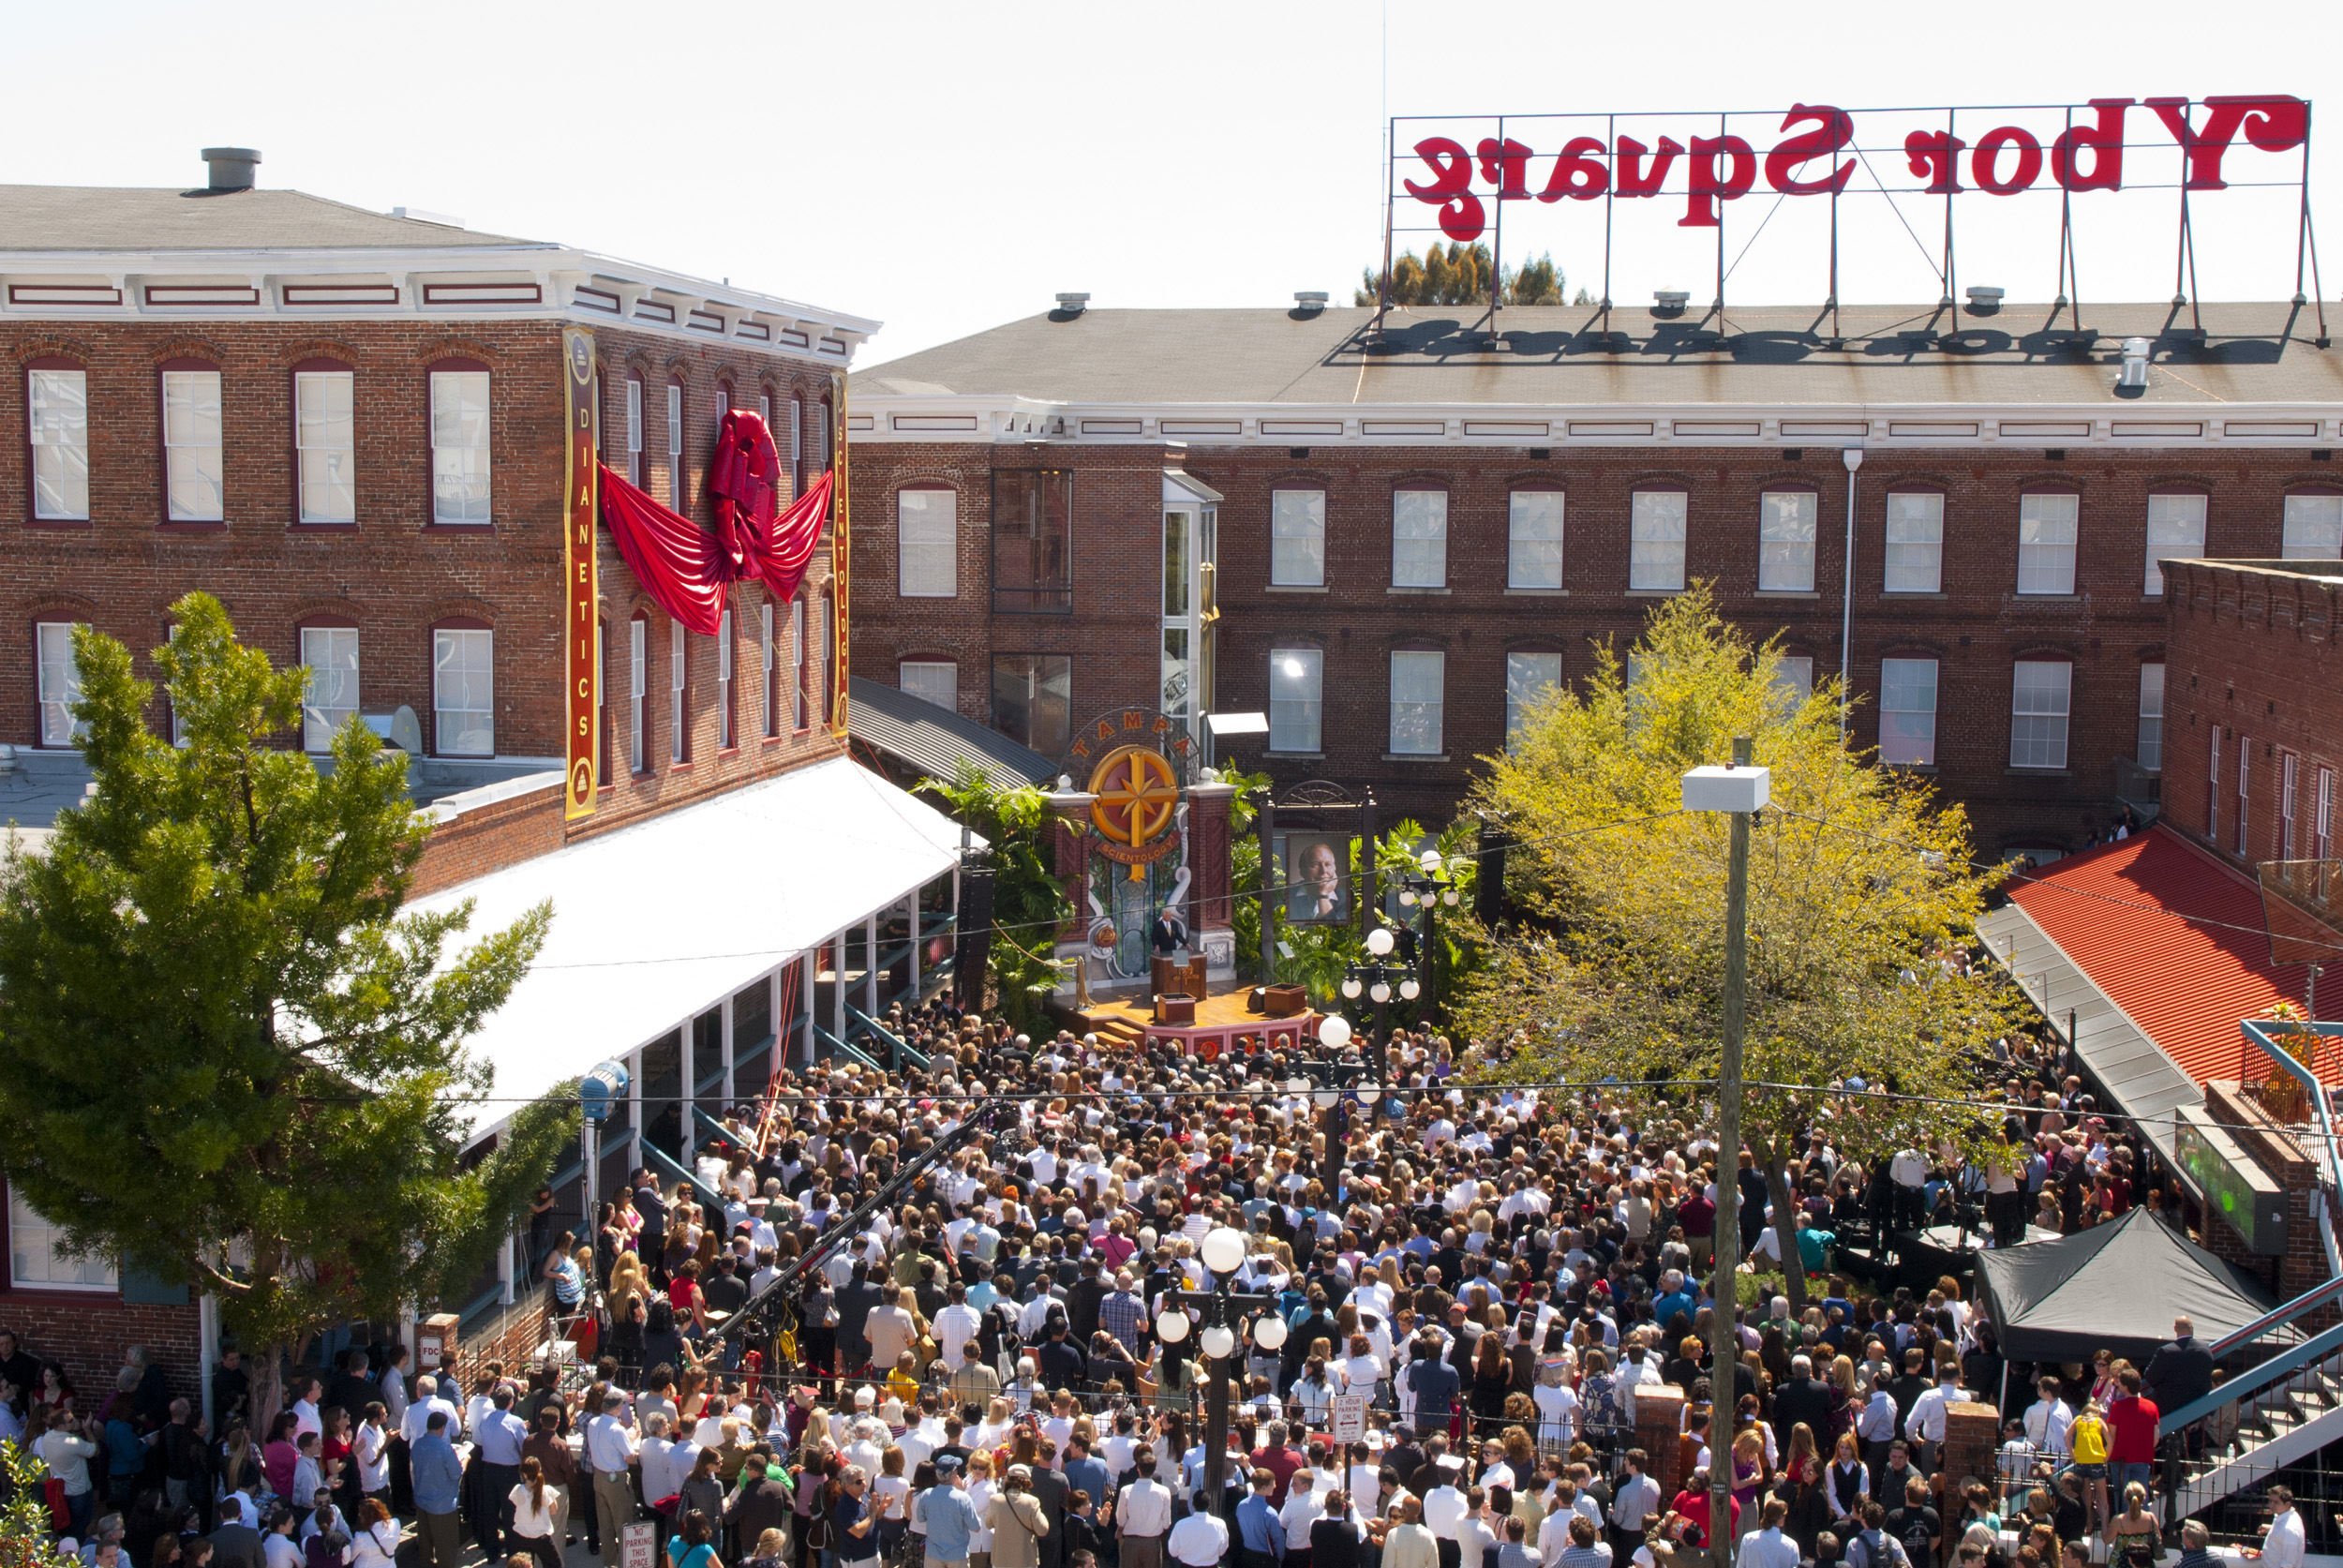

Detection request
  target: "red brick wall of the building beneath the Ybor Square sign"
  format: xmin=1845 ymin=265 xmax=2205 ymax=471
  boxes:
xmin=856 ymin=443 xmax=2334 ymax=851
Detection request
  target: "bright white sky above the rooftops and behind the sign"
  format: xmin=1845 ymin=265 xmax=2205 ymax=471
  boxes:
xmin=0 ymin=0 xmax=2343 ymax=364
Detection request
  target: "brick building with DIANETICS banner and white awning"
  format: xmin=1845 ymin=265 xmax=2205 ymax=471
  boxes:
xmin=0 ymin=150 xmax=956 ymax=1396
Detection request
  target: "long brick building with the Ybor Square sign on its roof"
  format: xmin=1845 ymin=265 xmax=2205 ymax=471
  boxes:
xmin=851 ymin=292 xmax=2343 ymax=858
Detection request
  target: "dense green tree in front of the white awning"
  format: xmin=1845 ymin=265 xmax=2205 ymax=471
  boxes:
xmin=0 ymin=593 xmax=576 ymax=1420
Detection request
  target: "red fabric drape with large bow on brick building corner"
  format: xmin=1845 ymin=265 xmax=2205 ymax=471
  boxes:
xmin=603 ymin=408 xmax=829 ymax=637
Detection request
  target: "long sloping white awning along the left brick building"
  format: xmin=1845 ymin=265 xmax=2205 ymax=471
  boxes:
xmin=410 ymin=757 xmax=982 ymax=1132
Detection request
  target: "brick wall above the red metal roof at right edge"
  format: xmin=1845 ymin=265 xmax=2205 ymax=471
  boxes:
xmin=2163 ymin=560 xmax=2343 ymax=881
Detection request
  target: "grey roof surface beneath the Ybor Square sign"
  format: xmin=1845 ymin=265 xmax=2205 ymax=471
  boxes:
xmin=853 ymin=303 xmax=2343 ymax=411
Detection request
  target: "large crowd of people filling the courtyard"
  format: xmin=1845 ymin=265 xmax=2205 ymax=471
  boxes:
xmin=0 ymin=984 xmax=2304 ymax=1568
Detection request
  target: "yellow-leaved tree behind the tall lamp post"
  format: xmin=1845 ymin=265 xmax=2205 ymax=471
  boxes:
xmin=1462 ymin=584 xmax=2010 ymax=1312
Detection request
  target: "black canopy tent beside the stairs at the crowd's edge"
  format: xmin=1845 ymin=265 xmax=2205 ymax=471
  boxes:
xmin=1977 ymin=1209 xmax=2277 ymax=1366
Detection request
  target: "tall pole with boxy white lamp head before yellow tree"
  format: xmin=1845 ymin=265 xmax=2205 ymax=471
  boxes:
xmin=1685 ymin=736 xmax=1788 ymax=1568
